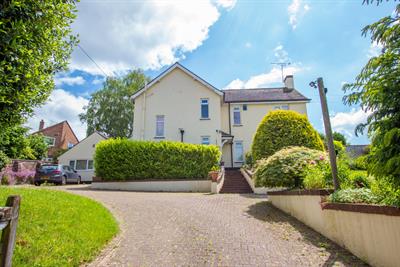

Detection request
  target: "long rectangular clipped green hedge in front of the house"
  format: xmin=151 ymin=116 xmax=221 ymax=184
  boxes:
xmin=94 ymin=139 xmax=221 ymax=181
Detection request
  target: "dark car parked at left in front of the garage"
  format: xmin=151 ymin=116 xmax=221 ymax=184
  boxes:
xmin=34 ymin=164 xmax=81 ymax=185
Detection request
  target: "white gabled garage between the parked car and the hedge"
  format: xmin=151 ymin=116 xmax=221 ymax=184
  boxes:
xmin=58 ymin=132 xmax=107 ymax=182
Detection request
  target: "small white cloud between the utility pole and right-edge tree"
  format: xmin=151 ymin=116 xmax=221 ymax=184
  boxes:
xmin=331 ymin=109 xmax=371 ymax=139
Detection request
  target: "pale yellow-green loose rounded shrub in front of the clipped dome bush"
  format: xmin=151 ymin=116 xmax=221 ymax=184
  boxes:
xmin=254 ymin=147 xmax=327 ymax=187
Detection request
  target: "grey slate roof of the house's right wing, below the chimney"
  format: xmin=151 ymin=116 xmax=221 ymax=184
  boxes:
xmin=223 ymin=87 xmax=310 ymax=103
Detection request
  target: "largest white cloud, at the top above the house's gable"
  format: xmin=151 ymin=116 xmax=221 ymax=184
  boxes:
xmin=70 ymin=0 xmax=231 ymax=75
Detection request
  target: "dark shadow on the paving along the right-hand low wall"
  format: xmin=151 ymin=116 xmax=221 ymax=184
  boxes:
xmin=246 ymin=201 xmax=369 ymax=266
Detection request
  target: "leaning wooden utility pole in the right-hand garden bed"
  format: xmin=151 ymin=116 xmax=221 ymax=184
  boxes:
xmin=317 ymin=78 xmax=340 ymax=191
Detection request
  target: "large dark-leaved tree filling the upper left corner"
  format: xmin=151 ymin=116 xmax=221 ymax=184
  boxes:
xmin=0 ymin=0 xmax=77 ymax=129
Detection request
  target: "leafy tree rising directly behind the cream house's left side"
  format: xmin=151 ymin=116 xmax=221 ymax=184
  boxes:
xmin=79 ymin=70 xmax=149 ymax=137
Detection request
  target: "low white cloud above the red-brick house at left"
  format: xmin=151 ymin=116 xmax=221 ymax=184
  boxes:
xmin=27 ymin=89 xmax=89 ymax=140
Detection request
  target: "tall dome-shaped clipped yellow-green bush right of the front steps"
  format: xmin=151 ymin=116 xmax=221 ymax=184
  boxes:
xmin=251 ymin=110 xmax=324 ymax=160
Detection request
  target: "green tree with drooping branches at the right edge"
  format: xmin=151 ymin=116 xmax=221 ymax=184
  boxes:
xmin=343 ymin=5 xmax=400 ymax=184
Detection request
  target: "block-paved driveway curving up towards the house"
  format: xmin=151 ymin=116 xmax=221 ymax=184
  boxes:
xmin=64 ymin=186 xmax=364 ymax=266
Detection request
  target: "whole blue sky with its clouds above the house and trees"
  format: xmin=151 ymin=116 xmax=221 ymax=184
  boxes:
xmin=28 ymin=0 xmax=396 ymax=144
